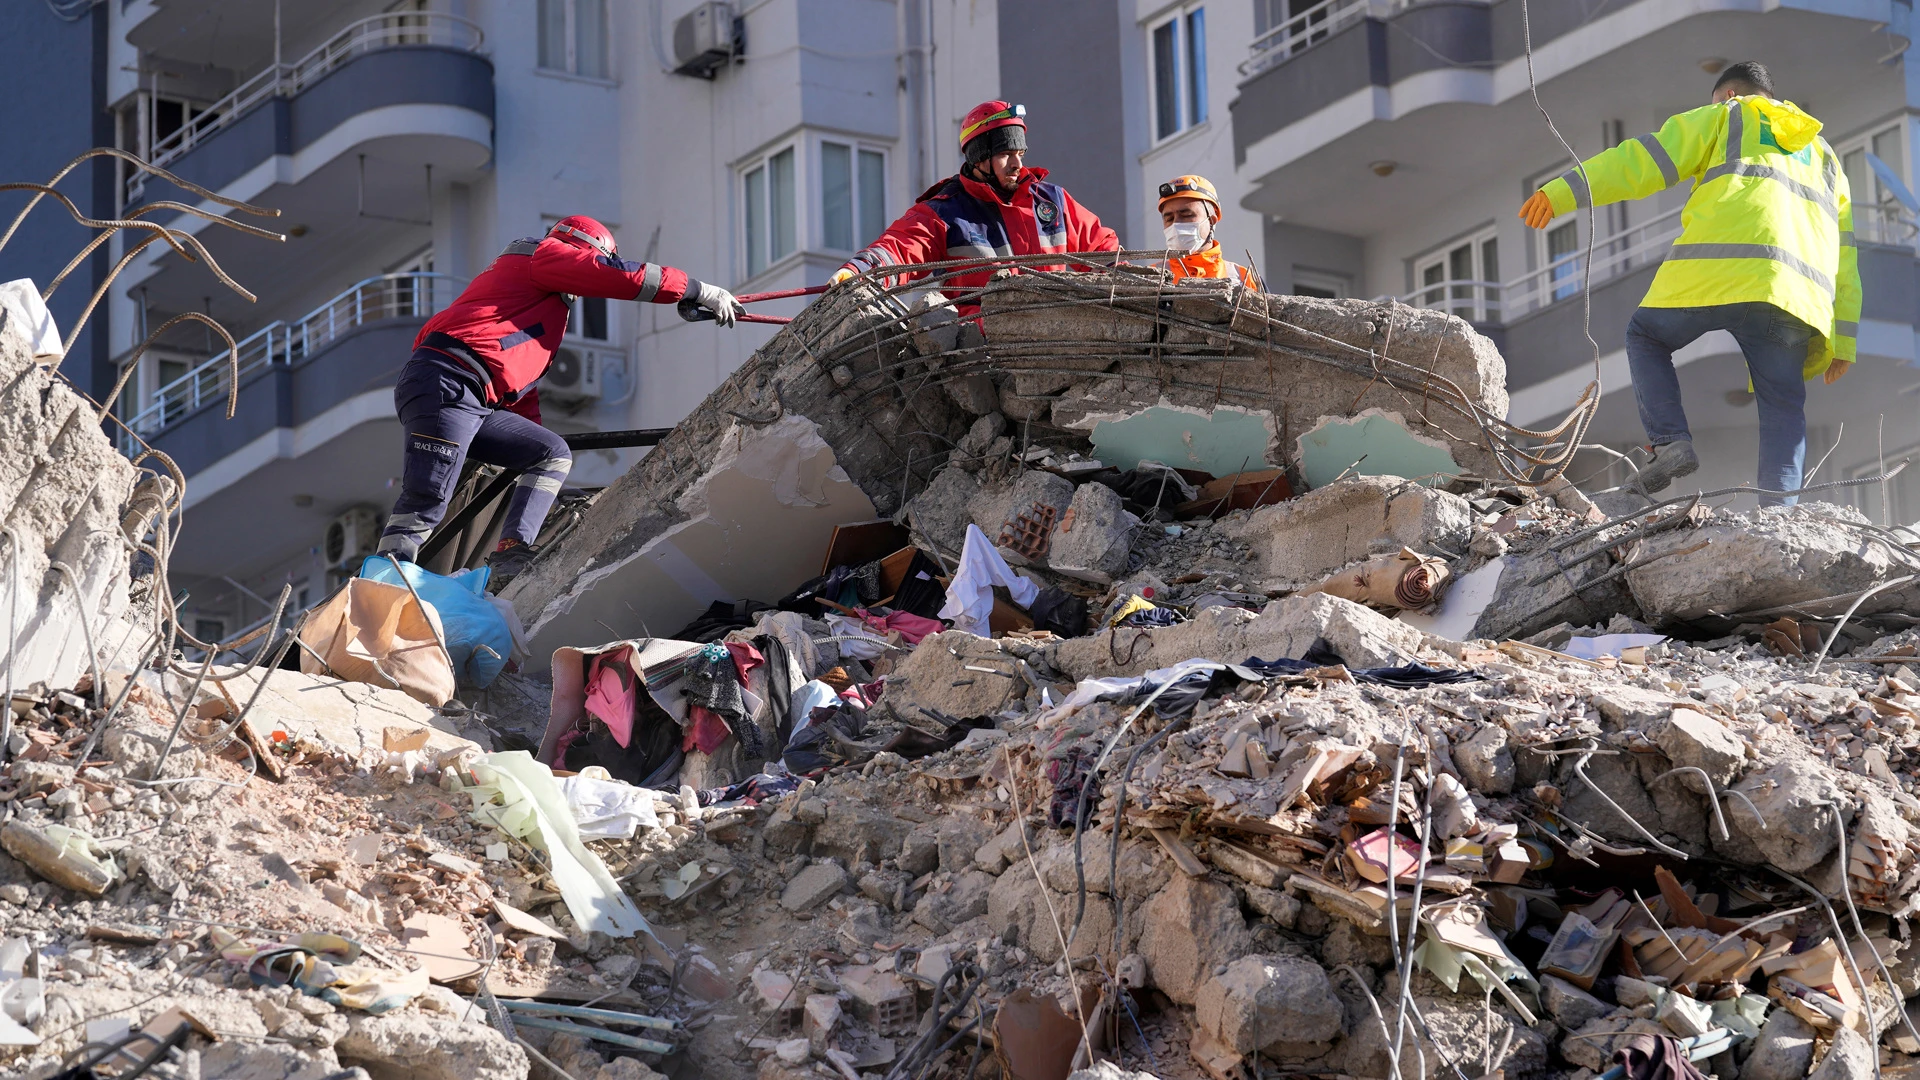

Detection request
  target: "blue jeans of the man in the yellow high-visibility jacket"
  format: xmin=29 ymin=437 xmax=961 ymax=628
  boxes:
xmin=1626 ymin=304 xmax=1812 ymax=505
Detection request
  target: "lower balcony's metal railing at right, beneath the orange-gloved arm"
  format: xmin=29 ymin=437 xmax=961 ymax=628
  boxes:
xmin=1380 ymin=208 xmax=1682 ymax=323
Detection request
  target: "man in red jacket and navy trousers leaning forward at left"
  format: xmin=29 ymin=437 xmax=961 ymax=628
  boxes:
xmin=380 ymin=215 xmax=743 ymax=586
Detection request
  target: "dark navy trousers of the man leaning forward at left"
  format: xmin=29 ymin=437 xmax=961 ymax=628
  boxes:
xmin=380 ymin=348 xmax=574 ymax=559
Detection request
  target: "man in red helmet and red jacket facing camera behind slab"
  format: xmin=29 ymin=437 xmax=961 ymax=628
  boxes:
xmin=833 ymin=102 xmax=1119 ymax=311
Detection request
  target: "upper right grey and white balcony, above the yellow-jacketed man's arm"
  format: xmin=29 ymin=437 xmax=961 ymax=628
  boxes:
xmin=1233 ymin=0 xmax=1907 ymax=238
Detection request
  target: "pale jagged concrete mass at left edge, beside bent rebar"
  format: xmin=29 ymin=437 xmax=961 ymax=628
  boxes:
xmin=0 ymin=319 xmax=137 ymax=686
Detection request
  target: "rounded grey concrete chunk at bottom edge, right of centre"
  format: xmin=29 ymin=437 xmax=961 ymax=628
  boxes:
xmin=1194 ymin=953 xmax=1346 ymax=1057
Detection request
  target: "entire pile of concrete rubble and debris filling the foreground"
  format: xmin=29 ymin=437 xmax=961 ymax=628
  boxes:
xmin=0 ymin=273 xmax=1920 ymax=1080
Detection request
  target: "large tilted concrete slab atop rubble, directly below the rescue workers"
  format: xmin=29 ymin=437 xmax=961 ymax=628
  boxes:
xmin=505 ymin=269 xmax=1507 ymax=653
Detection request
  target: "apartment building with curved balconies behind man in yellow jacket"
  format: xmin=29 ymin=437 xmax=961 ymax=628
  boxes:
xmin=1233 ymin=0 xmax=1920 ymax=523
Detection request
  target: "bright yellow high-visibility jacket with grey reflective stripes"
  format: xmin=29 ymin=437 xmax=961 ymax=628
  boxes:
xmin=1540 ymin=94 xmax=1860 ymax=379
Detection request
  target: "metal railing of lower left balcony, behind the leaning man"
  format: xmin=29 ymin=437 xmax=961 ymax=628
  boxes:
xmin=121 ymin=273 xmax=467 ymax=452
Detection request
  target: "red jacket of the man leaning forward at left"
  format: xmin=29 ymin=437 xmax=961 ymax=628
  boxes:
xmin=413 ymin=236 xmax=689 ymax=407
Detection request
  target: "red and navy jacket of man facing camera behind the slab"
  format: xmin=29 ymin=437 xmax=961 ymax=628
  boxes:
xmin=847 ymin=169 xmax=1119 ymax=309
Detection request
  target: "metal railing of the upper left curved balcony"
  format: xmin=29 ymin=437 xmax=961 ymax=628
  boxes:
xmin=127 ymin=12 xmax=486 ymax=200
